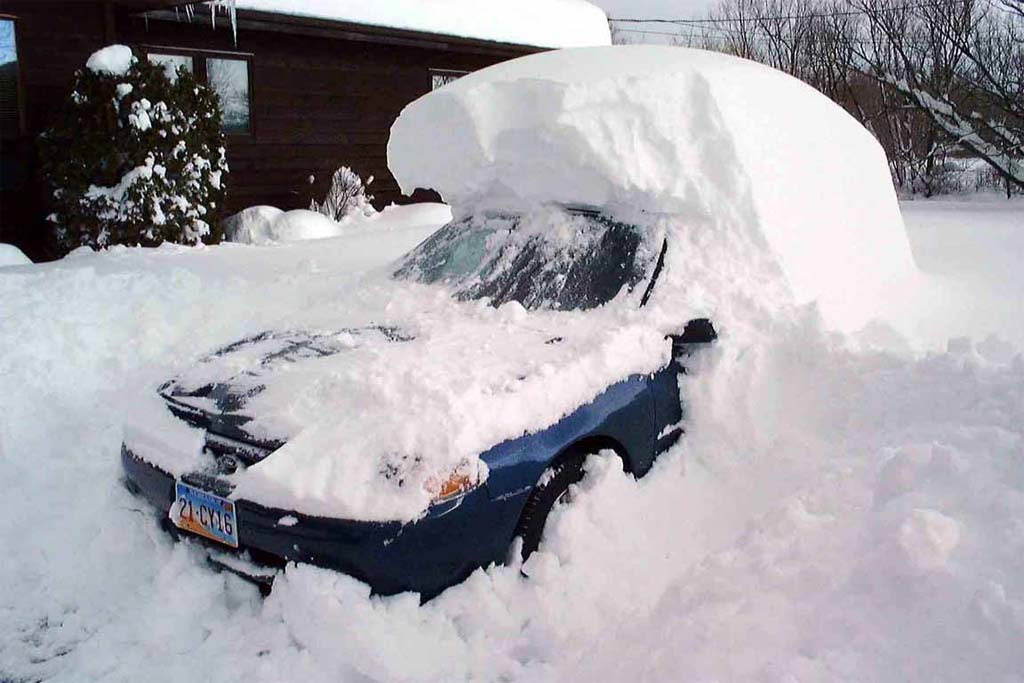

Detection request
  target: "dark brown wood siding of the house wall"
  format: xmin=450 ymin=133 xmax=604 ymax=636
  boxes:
xmin=0 ymin=2 xmax=536 ymax=255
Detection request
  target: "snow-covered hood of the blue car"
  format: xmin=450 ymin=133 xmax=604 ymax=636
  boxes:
xmin=131 ymin=262 xmax=670 ymax=520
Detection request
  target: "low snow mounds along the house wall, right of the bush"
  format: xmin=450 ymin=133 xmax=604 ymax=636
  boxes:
xmin=224 ymin=203 xmax=452 ymax=245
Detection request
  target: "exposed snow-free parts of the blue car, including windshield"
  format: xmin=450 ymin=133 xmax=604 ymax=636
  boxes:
xmin=122 ymin=210 xmax=716 ymax=599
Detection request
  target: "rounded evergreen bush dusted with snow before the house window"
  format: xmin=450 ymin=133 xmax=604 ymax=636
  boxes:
xmin=42 ymin=45 xmax=227 ymax=251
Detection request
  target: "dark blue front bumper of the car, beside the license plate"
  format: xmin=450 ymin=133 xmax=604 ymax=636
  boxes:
xmin=121 ymin=444 xmax=523 ymax=599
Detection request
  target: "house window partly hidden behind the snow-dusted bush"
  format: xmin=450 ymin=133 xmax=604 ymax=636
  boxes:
xmin=145 ymin=48 xmax=252 ymax=135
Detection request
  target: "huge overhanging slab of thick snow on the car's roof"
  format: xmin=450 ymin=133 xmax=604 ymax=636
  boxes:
xmin=388 ymin=46 xmax=912 ymax=329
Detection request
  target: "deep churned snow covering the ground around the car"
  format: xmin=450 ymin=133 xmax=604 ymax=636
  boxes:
xmin=0 ymin=196 xmax=1024 ymax=681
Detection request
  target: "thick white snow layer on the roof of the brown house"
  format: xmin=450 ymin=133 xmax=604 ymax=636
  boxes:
xmin=228 ymin=0 xmax=611 ymax=47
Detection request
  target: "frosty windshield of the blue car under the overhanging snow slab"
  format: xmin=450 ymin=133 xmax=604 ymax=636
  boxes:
xmin=394 ymin=211 xmax=653 ymax=310
